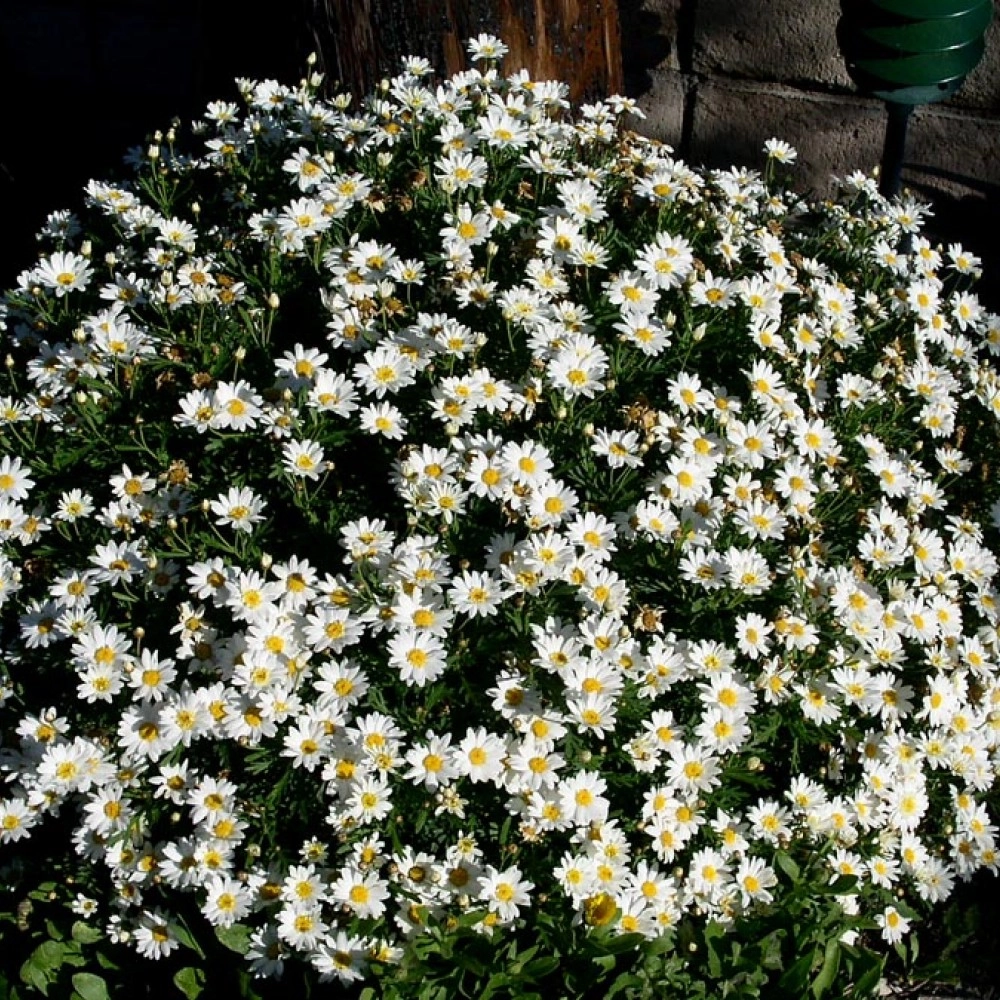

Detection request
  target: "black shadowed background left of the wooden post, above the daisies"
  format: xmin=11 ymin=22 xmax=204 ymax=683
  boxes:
xmin=0 ymin=0 xmax=310 ymax=288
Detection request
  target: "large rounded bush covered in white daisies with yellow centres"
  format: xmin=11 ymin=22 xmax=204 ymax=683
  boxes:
xmin=0 ymin=36 xmax=1000 ymax=997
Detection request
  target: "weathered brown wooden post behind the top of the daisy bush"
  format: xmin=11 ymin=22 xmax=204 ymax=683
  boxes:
xmin=306 ymin=0 xmax=624 ymax=102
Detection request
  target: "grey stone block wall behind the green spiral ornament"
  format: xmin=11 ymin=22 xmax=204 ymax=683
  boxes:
xmin=619 ymin=0 xmax=1000 ymax=292
